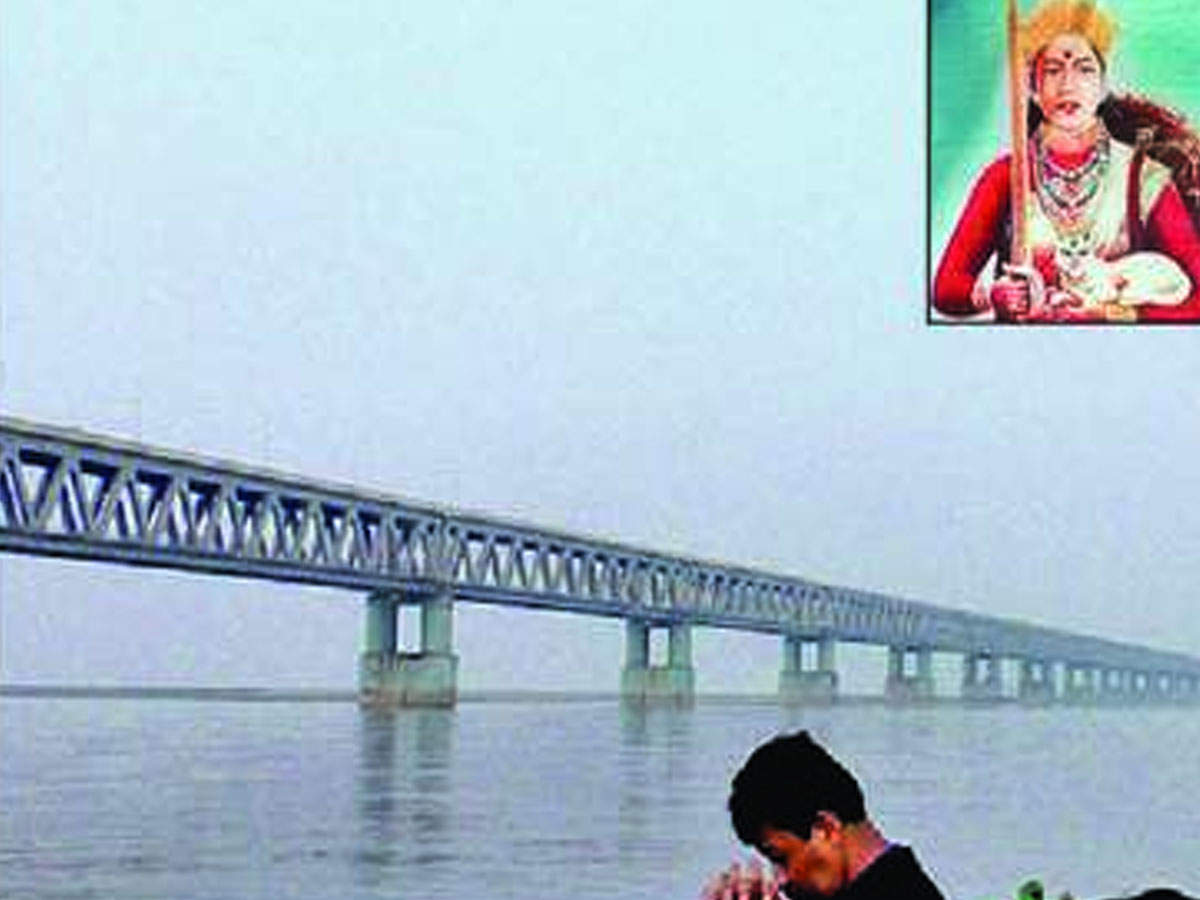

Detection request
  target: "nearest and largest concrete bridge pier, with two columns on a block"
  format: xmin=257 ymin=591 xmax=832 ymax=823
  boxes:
xmin=359 ymin=590 xmax=458 ymax=707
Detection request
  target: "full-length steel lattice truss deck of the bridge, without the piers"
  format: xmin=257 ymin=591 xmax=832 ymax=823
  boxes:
xmin=0 ymin=418 xmax=1200 ymax=674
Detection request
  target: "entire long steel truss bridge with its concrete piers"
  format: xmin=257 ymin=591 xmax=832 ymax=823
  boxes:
xmin=0 ymin=416 xmax=1200 ymax=706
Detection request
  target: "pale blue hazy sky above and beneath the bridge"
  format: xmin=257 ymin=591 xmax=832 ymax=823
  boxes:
xmin=0 ymin=0 xmax=1200 ymax=690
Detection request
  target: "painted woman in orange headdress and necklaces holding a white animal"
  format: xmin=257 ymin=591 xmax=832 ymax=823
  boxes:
xmin=932 ymin=0 xmax=1200 ymax=323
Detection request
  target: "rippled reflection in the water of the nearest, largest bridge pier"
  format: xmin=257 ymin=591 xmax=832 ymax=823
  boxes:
xmin=354 ymin=709 xmax=455 ymax=890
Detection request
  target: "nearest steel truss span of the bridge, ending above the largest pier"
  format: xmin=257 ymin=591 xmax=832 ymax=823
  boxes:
xmin=0 ymin=420 xmax=444 ymax=588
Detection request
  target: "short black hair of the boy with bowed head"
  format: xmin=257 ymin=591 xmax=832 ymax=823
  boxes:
xmin=730 ymin=731 xmax=866 ymax=846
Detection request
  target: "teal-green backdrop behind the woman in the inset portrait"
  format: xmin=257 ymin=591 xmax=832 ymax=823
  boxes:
xmin=929 ymin=0 xmax=1200 ymax=266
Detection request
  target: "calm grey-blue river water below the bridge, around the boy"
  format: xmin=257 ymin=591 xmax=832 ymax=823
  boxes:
xmin=0 ymin=698 xmax=1200 ymax=900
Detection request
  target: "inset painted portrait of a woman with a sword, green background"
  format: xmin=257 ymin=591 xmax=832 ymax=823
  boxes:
xmin=928 ymin=0 xmax=1200 ymax=324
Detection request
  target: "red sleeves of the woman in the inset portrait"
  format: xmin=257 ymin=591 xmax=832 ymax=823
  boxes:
xmin=932 ymin=154 xmax=1200 ymax=322
